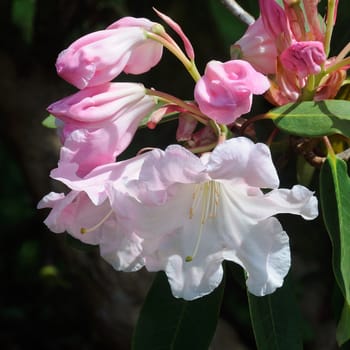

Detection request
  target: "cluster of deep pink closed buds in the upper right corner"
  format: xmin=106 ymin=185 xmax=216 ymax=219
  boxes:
xmin=231 ymin=0 xmax=347 ymax=106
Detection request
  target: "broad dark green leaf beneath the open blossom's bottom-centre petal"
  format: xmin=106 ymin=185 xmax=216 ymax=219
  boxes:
xmin=132 ymin=272 xmax=224 ymax=350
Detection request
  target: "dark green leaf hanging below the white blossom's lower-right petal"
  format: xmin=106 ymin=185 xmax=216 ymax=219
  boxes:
xmin=248 ymin=278 xmax=303 ymax=350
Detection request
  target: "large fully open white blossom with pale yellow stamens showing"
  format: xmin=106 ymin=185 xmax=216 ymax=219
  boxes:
xmin=103 ymin=138 xmax=318 ymax=300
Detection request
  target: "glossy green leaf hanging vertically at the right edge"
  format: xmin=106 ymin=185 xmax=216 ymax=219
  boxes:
xmin=320 ymin=155 xmax=350 ymax=305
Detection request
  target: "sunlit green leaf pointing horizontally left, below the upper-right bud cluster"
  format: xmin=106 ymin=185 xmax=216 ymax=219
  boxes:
xmin=266 ymin=100 xmax=350 ymax=137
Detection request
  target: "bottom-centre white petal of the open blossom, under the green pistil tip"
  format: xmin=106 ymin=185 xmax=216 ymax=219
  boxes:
xmin=146 ymin=219 xmax=223 ymax=300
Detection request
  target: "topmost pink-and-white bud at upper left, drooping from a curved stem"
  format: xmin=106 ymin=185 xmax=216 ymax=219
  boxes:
xmin=56 ymin=17 xmax=163 ymax=89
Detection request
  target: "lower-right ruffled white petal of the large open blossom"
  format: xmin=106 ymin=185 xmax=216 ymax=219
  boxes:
xmin=217 ymin=185 xmax=290 ymax=295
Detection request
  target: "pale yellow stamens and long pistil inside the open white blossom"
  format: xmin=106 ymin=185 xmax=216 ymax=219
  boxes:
xmin=185 ymin=181 xmax=220 ymax=262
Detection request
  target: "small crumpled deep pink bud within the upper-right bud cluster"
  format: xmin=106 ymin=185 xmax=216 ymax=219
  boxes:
xmin=280 ymin=41 xmax=326 ymax=78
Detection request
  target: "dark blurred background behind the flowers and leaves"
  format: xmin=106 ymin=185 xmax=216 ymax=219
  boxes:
xmin=0 ymin=0 xmax=350 ymax=350
